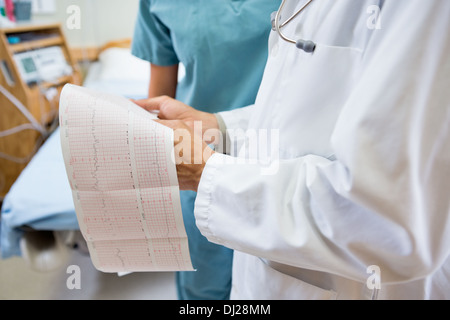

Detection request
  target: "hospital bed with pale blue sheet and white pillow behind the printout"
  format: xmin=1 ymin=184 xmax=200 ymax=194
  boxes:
xmin=0 ymin=45 xmax=150 ymax=271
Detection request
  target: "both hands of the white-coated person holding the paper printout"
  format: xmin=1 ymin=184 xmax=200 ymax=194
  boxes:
xmin=133 ymin=96 xmax=219 ymax=191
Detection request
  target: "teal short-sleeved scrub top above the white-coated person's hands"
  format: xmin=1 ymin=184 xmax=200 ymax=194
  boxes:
xmin=132 ymin=0 xmax=280 ymax=113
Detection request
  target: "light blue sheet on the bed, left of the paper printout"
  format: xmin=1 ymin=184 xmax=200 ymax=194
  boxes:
xmin=0 ymin=129 xmax=79 ymax=258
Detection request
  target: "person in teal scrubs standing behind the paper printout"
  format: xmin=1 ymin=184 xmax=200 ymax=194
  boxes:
xmin=132 ymin=0 xmax=281 ymax=300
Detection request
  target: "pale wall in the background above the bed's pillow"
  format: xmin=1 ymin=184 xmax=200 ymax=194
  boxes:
xmin=32 ymin=0 xmax=139 ymax=47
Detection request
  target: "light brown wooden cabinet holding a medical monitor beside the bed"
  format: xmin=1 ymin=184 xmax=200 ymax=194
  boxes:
xmin=0 ymin=24 xmax=81 ymax=200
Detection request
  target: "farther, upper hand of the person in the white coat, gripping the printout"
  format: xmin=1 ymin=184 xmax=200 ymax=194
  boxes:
xmin=132 ymin=96 xmax=219 ymax=133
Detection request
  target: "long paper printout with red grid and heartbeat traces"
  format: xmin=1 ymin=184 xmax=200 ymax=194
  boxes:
xmin=60 ymin=85 xmax=193 ymax=272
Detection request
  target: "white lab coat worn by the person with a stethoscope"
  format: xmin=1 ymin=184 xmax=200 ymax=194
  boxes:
xmin=195 ymin=0 xmax=450 ymax=299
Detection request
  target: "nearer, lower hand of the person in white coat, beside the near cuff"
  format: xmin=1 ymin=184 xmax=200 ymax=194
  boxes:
xmin=155 ymin=120 xmax=214 ymax=192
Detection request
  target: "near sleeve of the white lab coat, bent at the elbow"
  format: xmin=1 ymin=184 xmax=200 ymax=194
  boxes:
xmin=195 ymin=1 xmax=450 ymax=283
